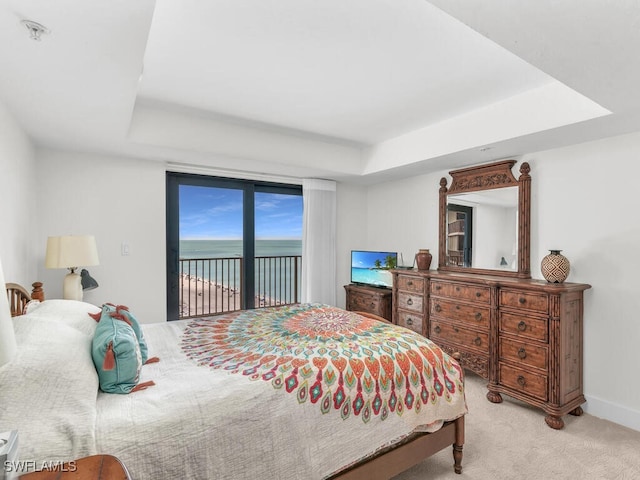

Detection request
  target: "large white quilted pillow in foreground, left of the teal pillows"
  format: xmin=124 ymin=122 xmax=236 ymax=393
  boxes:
xmin=0 ymin=316 xmax=98 ymax=468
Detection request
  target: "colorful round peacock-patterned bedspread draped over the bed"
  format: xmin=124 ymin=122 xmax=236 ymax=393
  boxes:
xmin=181 ymin=304 xmax=466 ymax=423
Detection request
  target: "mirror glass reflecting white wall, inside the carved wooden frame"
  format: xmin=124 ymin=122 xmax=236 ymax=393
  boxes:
xmin=447 ymin=186 xmax=518 ymax=271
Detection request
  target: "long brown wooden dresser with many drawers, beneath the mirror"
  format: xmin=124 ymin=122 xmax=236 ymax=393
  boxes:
xmin=393 ymin=270 xmax=590 ymax=429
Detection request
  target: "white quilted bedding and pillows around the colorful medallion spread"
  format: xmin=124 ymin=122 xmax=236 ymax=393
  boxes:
xmin=0 ymin=302 xmax=466 ymax=480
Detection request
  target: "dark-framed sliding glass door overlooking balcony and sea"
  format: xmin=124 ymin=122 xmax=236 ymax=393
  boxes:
xmin=167 ymin=173 xmax=302 ymax=320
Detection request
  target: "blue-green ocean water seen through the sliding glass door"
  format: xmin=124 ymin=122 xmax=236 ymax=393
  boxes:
xmin=180 ymin=239 xmax=302 ymax=302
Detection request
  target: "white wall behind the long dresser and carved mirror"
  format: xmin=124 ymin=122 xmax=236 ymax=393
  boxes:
xmin=367 ymin=128 xmax=640 ymax=430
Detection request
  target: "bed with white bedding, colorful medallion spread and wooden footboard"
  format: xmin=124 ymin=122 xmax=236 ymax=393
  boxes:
xmin=0 ymin=286 xmax=467 ymax=480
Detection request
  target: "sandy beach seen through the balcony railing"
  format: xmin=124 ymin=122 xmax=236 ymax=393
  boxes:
xmin=180 ymin=274 xmax=280 ymax=318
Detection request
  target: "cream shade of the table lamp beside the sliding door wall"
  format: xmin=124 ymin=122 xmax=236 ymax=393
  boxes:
xmin=44 ymin=235 xmax=100 ymax=268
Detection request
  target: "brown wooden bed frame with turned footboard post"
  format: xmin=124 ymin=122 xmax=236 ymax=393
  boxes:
xmin=6 ymin=282 xmax=464 ymax=480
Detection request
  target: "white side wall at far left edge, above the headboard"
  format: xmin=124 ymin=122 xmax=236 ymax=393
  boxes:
xmin=0 ymin=102 xmax=38 ymax=282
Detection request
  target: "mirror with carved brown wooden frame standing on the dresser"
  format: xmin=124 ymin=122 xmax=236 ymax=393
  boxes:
xmin=438 ymin=160 xmax=531 ymax=278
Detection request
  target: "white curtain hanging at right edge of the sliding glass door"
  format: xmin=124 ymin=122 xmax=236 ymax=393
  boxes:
xmin=301 ymin=179 xmax=336 ymax=305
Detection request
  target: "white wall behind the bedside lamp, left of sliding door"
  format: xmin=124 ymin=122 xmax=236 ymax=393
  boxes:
xmin=35 ymin=151 xmax=166 ymax=323
